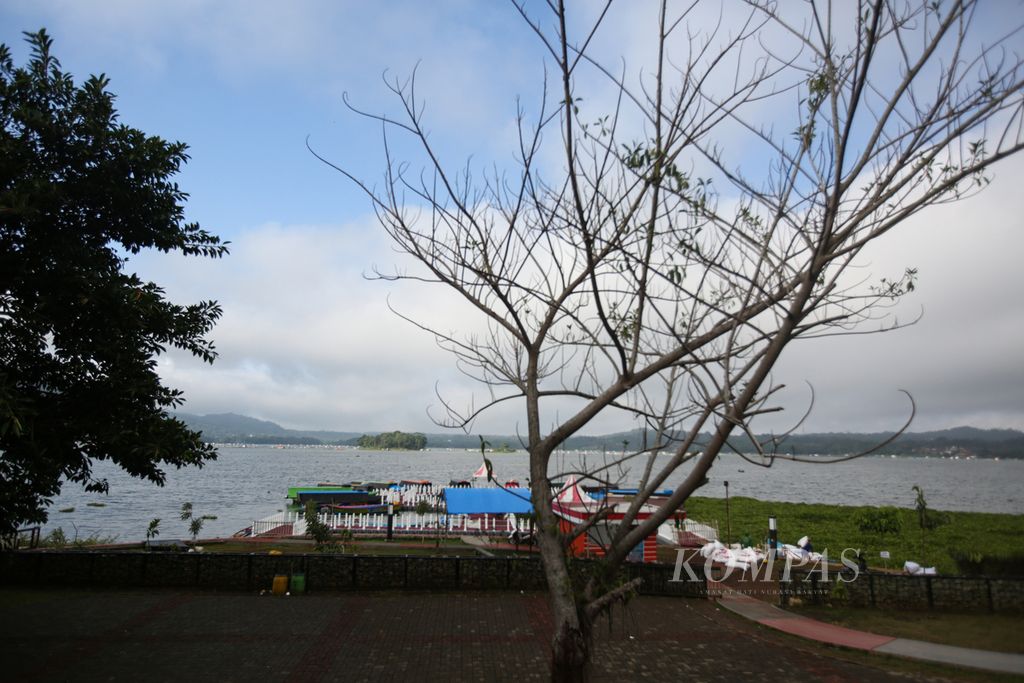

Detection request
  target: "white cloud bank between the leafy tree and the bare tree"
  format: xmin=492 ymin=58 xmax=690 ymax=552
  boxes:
xmin=133 ymin=222 xmax=481 ymax=429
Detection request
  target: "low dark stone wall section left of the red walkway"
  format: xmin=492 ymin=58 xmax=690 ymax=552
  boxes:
xmin=0 ymin=551 xmax=707 ymax=596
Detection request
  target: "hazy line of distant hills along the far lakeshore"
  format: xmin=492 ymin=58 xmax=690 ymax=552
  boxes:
xmin=177 ymin=413 xmax=1024 ymax=458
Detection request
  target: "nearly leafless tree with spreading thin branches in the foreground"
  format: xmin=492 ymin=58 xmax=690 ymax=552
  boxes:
xmin=315 ymin=0 xmax=1024 ymax=679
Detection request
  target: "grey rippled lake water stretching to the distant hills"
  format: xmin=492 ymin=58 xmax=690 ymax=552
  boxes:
xmin=44 ymin=446 xmax=1024 ymax=541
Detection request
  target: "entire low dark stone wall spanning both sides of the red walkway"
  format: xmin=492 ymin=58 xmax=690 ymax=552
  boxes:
xmin=8 ymin=551 xmax=1024 ymax=612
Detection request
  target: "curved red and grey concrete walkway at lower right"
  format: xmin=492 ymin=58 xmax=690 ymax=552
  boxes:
xmin=719 ymin=591 xmax=1024 ymax=674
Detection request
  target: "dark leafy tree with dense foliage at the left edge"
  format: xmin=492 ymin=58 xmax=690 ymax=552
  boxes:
xmin=0 ymin=31 xmax=226 ymax=532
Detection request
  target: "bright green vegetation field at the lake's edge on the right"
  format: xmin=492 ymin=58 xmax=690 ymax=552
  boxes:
xmin=686 ymin=497 xmax=1024 ymax=574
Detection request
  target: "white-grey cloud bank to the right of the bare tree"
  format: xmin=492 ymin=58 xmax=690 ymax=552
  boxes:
xmin=777 ymin=154 xmax=1024 ymax=430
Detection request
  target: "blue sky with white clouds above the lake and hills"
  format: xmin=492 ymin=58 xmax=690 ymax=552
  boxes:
xmin=0 ymin=0 xmax=1024 ymax=433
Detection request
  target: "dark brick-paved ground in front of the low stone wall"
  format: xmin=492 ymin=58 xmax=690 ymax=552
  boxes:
xmin=0 ymin=589 xmax=906 ymax=683
